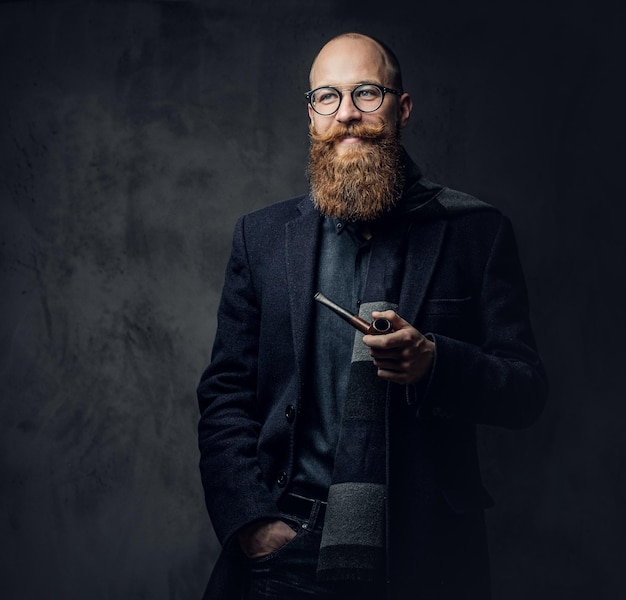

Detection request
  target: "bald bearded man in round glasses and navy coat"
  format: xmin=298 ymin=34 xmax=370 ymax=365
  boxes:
xmin=198 ymin=34 xmax=546 ymax=600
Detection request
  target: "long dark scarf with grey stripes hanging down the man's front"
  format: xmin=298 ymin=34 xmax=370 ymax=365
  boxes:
xmin=317 ymin=222 xmax=406 ymax=581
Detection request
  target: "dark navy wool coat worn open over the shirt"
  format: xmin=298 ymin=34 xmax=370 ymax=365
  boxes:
xmin=198 ymin=180 xmax=547 ymax=598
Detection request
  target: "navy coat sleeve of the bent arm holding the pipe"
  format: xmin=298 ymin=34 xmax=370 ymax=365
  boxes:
xmin=418 ymin=217 xmax=548 ymax=429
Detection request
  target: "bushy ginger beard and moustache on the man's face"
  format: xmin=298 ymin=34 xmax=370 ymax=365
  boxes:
xmin=307 ymin=123 xmax=404 ymax=221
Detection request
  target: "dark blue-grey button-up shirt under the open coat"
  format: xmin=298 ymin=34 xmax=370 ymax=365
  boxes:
xmin=293 ymin=217 xmax=371 ymax=498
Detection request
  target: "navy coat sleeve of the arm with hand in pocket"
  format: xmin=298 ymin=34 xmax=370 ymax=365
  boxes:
xmin=197 ymin=217 xmax=279 ymax=546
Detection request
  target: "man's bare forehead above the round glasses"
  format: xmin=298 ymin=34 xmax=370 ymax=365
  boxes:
xmin=311 ymin=38 xmax=391 ymax=88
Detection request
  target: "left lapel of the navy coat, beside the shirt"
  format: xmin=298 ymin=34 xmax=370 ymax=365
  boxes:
xmin=285 ymin=196 xmax=320 ymax=375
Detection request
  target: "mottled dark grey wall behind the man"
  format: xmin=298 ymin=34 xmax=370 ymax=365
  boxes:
xmin=0 ymin=0 xmax=626 ymax=600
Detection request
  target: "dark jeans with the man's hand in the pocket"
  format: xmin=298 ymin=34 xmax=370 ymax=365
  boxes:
xmin=244 ymin=501 xmax=385 ymax=600
